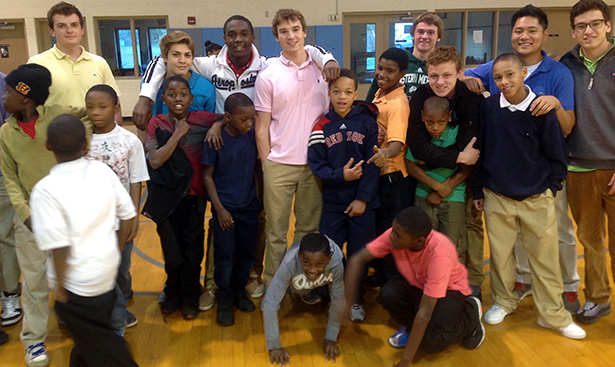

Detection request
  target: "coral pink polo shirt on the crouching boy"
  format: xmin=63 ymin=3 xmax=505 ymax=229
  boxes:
xmin=366 ymin=228 xmax=472 ymax=298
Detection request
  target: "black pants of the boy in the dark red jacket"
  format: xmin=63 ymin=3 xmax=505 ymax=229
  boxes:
xmin=156 ymin=195 xmax=205 ymax=303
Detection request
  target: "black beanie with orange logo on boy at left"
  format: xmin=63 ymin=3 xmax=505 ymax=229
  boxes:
xmin=4 ymin=64 xmax=51 ymax=105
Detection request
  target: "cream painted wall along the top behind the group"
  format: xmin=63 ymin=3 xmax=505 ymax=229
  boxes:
xmin=0 ymin=0 xmax=615 ymax=116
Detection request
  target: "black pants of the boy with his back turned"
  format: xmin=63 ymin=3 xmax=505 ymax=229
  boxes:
xmin=54 ymin=290 xmax=138 ymax=367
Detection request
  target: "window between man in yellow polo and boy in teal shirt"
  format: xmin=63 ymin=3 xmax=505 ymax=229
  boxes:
xmin=97 ymin=18 xmax=167 ymax=76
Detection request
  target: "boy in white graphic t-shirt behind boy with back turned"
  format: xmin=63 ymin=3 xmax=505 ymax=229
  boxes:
xmin=85 ymin=84 xmax=149 ymax=335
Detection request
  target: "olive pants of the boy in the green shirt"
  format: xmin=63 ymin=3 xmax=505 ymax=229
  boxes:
xmin=414 ymin=196 xmax=468 ymax=265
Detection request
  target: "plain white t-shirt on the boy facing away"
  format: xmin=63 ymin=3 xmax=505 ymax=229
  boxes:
xmin=30 ymin=158 xmax=136 ymax=297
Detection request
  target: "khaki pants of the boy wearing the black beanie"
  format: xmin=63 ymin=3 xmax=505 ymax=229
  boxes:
xmin=13 ymin=215 xmax=49 ymax=347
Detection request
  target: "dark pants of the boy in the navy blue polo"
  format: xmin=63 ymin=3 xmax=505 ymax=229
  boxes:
xmin=212 ymin=199 xmax=258 ymax=309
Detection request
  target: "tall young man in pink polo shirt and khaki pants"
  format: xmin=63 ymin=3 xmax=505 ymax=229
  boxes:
xmin=254 ymin=9 xmax=339 ymax=286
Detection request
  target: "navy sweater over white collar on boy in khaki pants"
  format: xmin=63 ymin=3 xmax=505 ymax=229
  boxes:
xmin=472 ymin=93 xmax=567 ymax=201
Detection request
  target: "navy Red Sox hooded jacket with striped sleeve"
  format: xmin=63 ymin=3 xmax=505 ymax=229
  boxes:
xmin=308 ymin=102 xmax=380 ymax=213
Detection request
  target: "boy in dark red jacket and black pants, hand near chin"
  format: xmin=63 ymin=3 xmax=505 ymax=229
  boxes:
xmin=144 ymin=76 xmax=218 ymax=320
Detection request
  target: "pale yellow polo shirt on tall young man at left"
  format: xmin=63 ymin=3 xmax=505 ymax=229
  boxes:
xmin=28 ymin=45 xmax=120 ymax=118
